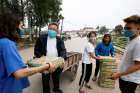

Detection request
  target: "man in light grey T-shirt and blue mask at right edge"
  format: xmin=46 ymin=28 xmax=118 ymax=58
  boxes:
xmin=111 ymin=15 xmax=140 ymax=93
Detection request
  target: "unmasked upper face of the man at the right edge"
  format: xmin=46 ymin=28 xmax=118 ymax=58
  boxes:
xmin=125 ymin=23 xmax=140 ymax=35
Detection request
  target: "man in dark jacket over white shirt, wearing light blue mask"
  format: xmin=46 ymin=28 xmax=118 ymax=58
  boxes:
xmin=34 ymin=23 xmax=66 ymax=93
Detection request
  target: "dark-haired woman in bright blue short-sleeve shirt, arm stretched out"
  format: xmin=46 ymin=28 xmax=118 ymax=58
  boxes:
xmin=0 ymin=14 xmax=54 ymax=93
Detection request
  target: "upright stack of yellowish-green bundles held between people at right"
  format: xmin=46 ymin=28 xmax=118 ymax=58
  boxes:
xmin=99 ymin=57 xmax=117 ymax=88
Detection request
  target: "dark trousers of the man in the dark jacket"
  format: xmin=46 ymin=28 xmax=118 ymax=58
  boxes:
xmin=42 ymin=68 xmax=62 ymax=93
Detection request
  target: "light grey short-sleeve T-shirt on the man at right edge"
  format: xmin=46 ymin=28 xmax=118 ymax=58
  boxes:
xmin=120 ymin=36 xmax=140 ymax=84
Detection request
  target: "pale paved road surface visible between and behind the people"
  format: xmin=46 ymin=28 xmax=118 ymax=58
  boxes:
xmin=20 ymin=38 xmax=139 ymax=93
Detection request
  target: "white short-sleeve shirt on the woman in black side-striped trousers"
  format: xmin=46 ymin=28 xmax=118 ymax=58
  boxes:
xmin=83 ymin=42 xmax=94 ymax=64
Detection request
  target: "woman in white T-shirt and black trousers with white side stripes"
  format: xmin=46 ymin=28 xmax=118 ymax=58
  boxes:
xmin=79 ymin=31 xmax=98 ymax=93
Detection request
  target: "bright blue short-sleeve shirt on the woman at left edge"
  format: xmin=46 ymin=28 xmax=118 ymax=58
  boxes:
xmin=0 ymin=38 xmax=29 ymax=93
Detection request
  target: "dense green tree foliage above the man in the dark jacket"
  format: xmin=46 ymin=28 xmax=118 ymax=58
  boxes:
xmin=27 ymin=0 xmax=62 ymax=27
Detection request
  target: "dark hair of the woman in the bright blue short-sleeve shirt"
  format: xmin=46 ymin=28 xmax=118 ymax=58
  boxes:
xmin=0 ymin=13 xmax=19 ymax=41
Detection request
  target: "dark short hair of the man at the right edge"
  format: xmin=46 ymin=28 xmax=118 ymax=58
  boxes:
xmin=123 ymin=15 xmax=140 ymax=25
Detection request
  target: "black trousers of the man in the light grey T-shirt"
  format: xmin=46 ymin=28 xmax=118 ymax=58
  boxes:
xmin=119 ymin=79 xmax=138 ymax=93
